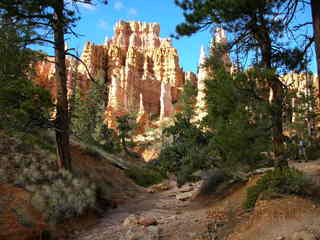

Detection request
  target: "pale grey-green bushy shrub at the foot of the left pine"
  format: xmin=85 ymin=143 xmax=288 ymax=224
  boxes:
xmin=14 ymin=161 xmax=96 ymax=223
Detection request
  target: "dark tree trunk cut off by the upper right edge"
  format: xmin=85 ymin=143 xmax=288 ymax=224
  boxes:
xmin=311 ymin=0 xmax=320 ymax=98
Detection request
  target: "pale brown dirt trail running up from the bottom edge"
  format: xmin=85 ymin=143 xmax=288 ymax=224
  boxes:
xmin=75 ymin=184 xmax=214 ymax=240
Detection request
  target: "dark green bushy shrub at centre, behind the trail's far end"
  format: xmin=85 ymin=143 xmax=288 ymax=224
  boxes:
xmin=156 ymin=115 xmax=214 ymax=186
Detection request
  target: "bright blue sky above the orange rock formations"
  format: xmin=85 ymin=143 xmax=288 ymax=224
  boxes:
xmin=66 ymin=0 xmax=316 ymax=72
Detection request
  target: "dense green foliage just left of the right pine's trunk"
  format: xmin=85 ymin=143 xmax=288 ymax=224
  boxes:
xmin=204 ymin=58 xmax=271 ymax=171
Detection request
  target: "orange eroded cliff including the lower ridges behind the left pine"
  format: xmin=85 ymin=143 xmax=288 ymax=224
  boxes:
xmin=37 ymin=21 xmax=190 ymax=127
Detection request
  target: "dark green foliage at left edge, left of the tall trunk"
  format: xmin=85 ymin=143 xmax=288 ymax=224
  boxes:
xmin=0 ymin=19 xmax=53 ymax=133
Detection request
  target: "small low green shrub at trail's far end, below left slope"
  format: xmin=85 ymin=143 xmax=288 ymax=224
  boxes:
xmin=125 ymin=166 xmax=164 ymax=187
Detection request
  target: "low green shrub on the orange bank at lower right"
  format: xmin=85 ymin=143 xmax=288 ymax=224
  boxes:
xmin=244 ymin=168 xmax=308 ymax=208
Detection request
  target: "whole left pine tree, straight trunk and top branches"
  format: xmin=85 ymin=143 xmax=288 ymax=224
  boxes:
xmin=0 ymin=0 xmax=107 ymax=170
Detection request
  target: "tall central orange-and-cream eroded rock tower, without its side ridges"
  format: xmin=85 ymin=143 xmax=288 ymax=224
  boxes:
xmin=104 ymin=21 xmax=185 ymax=126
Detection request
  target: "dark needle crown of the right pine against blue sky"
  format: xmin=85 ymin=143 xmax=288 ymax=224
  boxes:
xmin=175 ymin=0 xmax=303 ymax=66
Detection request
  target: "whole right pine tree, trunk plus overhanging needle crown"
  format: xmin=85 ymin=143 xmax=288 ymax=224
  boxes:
xmin=175 ymin=0 xmax=303 ymax=167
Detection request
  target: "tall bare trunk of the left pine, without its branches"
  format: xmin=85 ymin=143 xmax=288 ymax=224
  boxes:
xmin=53 ymin=0 xmax=71 ymax=170
